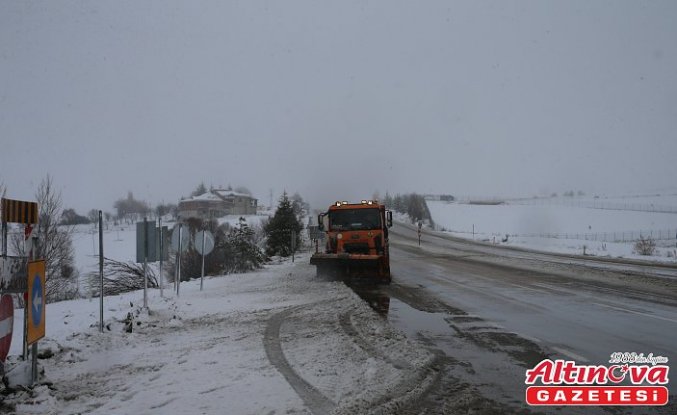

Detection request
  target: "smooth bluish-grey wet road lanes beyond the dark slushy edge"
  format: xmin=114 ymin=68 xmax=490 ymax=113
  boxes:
xmin=392 ymin=223 xmax=677 ymax=363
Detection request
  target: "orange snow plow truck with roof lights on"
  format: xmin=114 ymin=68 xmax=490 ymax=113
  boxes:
xmin=310 ymin=200 xmax=393 ymax=283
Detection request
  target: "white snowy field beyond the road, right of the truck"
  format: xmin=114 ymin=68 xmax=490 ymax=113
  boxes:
xmin=428 ymin=195 xmax=677 ymax=262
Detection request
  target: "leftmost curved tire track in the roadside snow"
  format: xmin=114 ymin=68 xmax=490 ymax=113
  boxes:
xmin=263 ymin=306 xmax=336 ymax=415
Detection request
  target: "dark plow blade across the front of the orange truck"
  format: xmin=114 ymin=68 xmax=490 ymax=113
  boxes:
xmin=310 ymin=254 xmax=390 ymax=282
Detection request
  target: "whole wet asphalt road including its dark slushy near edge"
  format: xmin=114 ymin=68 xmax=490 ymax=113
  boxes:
xmin=346 ymin=225 xmax=677 ymax=414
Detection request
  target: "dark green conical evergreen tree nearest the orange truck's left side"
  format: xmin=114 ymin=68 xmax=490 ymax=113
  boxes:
xmin=264 ymin=192 xmax=303 ymax=257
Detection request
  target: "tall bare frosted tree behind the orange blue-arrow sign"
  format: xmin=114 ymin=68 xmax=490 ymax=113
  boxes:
xmin=12 ymin=175 xmax=78 ymax=302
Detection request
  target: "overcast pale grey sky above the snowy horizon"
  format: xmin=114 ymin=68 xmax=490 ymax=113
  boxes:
xmin=0 ymin=0 xmax=677 ymax=211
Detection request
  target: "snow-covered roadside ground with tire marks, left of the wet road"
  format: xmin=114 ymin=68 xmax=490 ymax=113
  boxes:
xmin=4 ymin=255 xmax=431 ymax=414
